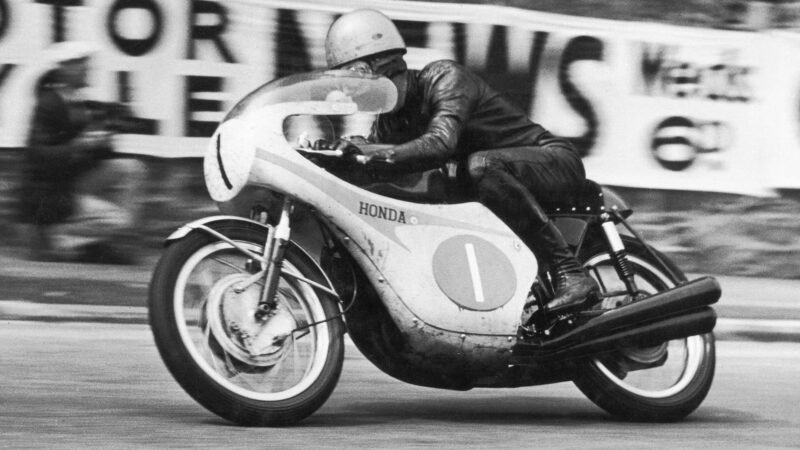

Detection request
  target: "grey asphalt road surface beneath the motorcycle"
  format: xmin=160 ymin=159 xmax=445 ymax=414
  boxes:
xmin=0 ymin=320 xmax=800 ymax=448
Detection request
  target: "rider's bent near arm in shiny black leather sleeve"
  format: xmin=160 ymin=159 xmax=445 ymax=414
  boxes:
xmin=374 ymin=61 xmax=479 ymax=171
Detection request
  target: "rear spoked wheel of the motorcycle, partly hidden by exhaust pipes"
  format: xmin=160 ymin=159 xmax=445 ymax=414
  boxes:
xmin=574 ymin=237 xmax=715 ymax=421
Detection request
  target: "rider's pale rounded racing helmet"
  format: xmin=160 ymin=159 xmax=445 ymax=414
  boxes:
xmin=325 ymin=9 xmax=406 ymax=69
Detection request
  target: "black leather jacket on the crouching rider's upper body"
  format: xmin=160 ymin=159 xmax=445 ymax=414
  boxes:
xmin=373 ymin=60 xmax=570 ymax=171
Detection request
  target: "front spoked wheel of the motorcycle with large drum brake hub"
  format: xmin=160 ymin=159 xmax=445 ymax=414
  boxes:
xmin=149 ymin=223 xmax=344 ymax=426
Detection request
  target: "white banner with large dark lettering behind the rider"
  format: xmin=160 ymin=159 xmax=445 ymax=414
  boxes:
xmin=0 ymin=0 xmax=800 ymax=195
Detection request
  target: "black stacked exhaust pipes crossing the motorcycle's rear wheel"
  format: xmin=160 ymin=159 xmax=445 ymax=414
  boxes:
xmin=513 ymin=277 xmax=722 ymax=364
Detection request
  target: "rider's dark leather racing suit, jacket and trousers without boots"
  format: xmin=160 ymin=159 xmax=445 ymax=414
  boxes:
xmin=373 ymin=61 xmax=585 ymax=263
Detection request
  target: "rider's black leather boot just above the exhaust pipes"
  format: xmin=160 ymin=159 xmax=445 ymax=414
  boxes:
xmin=530 ymin=221 xmax=600 ymax=314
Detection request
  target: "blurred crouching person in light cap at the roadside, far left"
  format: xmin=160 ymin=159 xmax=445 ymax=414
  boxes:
xmin=19 ymin=42 xmax=142 ymax=264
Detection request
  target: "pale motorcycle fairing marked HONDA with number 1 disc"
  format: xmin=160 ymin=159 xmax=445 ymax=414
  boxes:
xmin=204 ymin=101 xmax=536 ymax=335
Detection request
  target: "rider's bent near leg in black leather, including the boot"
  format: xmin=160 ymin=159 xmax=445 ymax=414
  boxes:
xmin=469 ymin=148 xmax=598 ymax=312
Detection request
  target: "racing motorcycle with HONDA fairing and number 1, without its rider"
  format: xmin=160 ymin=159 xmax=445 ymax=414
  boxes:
xmin=148 ymin=71 xmax=721 ymax=426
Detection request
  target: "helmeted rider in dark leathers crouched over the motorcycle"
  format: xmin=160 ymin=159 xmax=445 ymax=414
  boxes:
xmin=325 ymin=9 xmax=598 ymax=312
